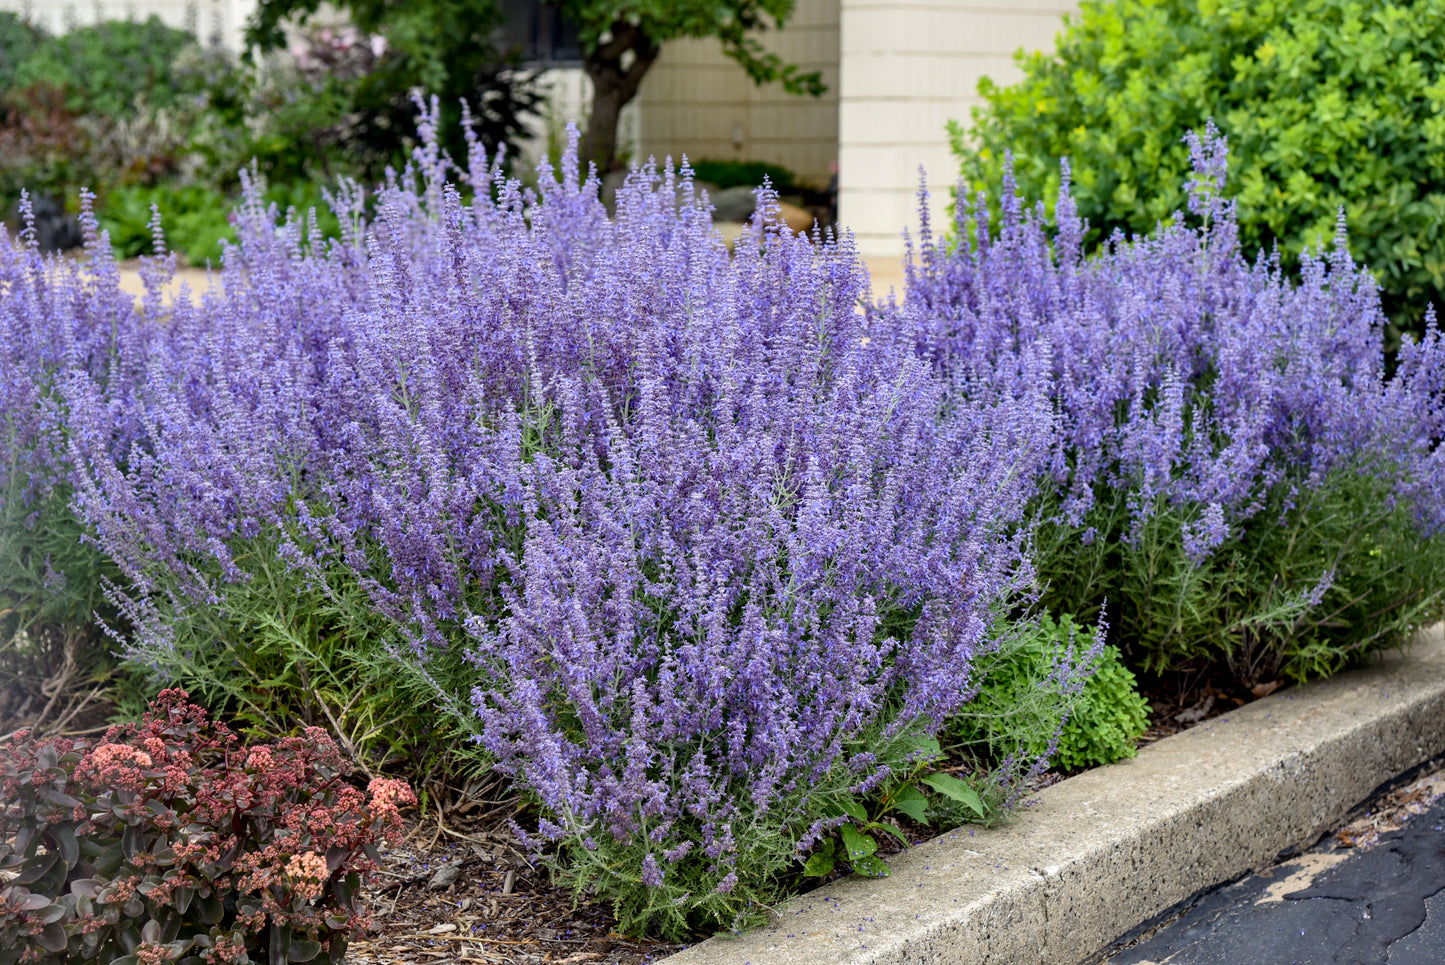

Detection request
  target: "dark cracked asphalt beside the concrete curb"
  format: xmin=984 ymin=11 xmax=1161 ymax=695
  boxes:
xmin=1103 ymin=774 xmax=1445 ymax=965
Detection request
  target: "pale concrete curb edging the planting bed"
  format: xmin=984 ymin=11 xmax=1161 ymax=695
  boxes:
xmin=663 ymin=626 xmax=1445 ymax=965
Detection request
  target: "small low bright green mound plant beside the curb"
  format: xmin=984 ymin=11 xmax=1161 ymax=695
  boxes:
xmin=948 ymin=614 xmax=1149 ymax=770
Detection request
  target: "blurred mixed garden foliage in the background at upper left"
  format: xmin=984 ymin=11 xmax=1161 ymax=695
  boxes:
xmin=0 ymin=4 xmax=540 ymax=264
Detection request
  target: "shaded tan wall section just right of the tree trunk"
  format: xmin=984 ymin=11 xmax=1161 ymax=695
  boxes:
xmin=636 ymin=0 xmax=840 ymax=188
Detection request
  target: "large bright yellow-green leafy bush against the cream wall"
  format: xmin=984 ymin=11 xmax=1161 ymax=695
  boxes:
xmin=951 ymin=0 xmax=1445 ymax=345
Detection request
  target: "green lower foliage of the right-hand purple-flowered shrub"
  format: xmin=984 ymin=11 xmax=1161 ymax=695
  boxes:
xmin=1038 ymin=467 xmax=1445 ymax=686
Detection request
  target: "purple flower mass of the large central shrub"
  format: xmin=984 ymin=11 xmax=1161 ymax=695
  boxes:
xmin=39 ymin=104 xmax=1069 ymax=923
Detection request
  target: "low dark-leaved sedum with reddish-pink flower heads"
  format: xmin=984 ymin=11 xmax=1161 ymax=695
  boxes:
xmin=0 ymin=691 xmax=415 ymax=965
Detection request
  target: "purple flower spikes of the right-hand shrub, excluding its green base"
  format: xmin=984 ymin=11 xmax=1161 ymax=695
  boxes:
xmin=905 ymin=127 xmax=1445 ymax=672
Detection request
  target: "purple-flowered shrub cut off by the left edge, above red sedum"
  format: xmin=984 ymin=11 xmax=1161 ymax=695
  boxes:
xmin=0 ymin=196 xmax=159 ymax=722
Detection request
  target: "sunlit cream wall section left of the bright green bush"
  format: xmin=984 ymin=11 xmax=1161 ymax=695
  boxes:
xmin=837 ymin=0 xmax=1078 ymax=257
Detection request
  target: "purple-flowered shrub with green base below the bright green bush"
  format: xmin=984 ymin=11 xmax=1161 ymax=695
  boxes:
xmin=907 ymin=129 xmax=1445 ymax=686
